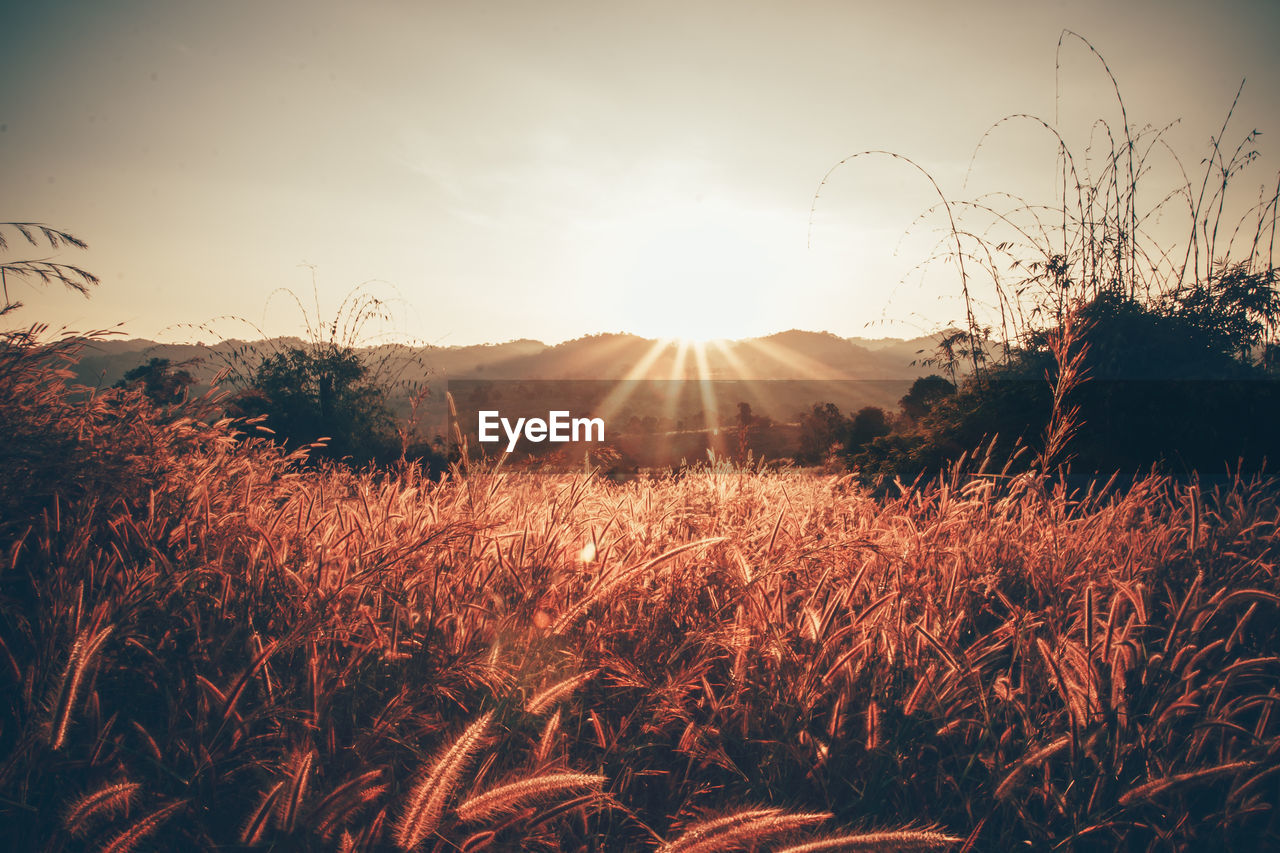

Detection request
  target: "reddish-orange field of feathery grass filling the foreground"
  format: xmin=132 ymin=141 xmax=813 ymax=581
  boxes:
xmin=0 ymin=347 xmax=1280 ymax=853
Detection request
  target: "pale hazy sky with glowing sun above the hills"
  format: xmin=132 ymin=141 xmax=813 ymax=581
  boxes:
xmin=0 ymin=0 xmax=1280 ymax=346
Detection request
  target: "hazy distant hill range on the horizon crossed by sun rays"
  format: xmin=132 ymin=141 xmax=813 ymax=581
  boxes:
xmin=62 ymin=329 xmax=932 ymax=421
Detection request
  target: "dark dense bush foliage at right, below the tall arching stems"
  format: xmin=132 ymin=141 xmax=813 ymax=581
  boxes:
xmin=854 ymin=285 xmax=1280 ymax=484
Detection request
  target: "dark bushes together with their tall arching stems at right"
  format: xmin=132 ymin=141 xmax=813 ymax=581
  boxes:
xmin=814 ymin=31 xmax=1280 ymax=488
